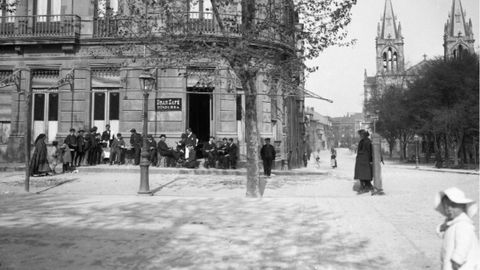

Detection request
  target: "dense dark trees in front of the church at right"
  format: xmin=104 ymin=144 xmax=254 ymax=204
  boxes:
xmin=365 ymin=53 xmax=479 ymax=166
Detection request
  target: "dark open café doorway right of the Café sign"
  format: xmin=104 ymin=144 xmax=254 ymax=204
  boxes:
xmin=187 ymin=87 xmax=213 ymax=143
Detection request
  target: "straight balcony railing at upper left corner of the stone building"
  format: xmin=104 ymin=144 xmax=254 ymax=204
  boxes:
xmin=0 ymin=15 xmax=80 ymax=44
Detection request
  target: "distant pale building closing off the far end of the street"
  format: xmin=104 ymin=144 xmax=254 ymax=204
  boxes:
xmin=331 ymin=113 xmax=364 ymax=147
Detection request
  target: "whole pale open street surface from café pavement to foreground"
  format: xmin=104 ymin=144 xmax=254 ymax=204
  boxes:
xmin=0 ymin=149 xmax=479 ymax=269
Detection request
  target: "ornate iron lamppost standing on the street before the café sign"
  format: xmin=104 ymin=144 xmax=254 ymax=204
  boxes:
xmin=138 ymin=70 xmax=155 ymax=195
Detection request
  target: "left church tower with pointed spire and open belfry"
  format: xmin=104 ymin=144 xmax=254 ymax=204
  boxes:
xmin=375 ymin=0 xmax=405 ymax=76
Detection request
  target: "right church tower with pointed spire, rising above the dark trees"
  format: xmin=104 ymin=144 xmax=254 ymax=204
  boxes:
xmin=443 ymin=0 xmax=475 ymax=58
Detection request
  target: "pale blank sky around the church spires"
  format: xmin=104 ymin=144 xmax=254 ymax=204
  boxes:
xmin=305 ymin=0 xmax=479 ymax=116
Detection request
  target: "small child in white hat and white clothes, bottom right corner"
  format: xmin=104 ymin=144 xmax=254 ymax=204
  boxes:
xmin=435 ymin=187 xmax=480 ymax=270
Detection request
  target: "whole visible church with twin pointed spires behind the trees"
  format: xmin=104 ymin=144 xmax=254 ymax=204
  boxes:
xmin=363 ymin=0 xmax=475 ymax=117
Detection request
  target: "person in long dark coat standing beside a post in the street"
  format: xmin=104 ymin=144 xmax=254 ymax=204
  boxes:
xmin=353 ymin=129 xmax=373 ymax=193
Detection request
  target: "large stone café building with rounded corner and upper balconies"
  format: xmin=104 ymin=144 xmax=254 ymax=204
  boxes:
xmin=0 ymin=0 xmax=304 ymax=167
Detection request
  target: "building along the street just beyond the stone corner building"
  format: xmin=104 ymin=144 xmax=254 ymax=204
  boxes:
xmin=305 ymin=107 xmax=334 ymax=152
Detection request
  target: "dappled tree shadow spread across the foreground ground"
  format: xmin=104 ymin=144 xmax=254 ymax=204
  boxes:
xmin=0 ymin=195 xmax=389 ymax=270
